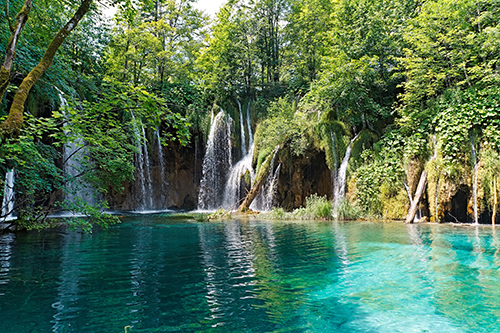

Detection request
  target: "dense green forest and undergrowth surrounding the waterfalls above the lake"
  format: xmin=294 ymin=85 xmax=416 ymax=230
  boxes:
xmin=0 ymin=0 xmax=500 ymax=229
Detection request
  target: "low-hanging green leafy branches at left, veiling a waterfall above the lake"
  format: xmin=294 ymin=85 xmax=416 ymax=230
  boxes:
xmin=0 ymin=78 xmax=190 ymax=231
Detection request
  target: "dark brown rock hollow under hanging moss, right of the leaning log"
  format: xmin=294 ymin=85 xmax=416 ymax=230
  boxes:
xmin=276 ymin=151 xmax=333 ymax=211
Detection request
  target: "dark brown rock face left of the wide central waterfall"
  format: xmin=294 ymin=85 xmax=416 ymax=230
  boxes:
xmin=106 ymin=138 xmax=203 ymax=210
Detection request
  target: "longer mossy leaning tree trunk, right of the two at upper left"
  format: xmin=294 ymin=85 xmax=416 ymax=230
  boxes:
xmin=0 ymin=0 xmax=93 ymax=135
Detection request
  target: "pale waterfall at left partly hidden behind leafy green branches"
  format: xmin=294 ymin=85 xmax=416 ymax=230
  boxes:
xmin=58 ymin=87 xmax=94 ymax=204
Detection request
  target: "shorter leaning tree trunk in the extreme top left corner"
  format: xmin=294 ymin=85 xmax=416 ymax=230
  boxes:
xmin=0 ymin=0 xmax=33 ymax=101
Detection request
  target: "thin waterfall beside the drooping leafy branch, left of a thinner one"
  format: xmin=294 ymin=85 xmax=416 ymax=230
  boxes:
xmin=130 ymin=112 xmax=154 ymax=210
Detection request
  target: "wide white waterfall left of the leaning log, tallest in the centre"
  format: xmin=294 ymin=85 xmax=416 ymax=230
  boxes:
xmin=198 ymin=110 xmax=232 ymax=209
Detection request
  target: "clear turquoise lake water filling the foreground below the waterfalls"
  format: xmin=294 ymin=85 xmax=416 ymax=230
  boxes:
xmin=0 ymin=216 xmax=500 ymax=333
